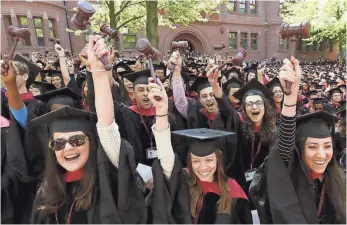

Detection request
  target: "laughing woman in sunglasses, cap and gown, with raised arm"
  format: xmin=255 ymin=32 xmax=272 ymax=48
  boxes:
xmin=28 ymin=37 xmax=147 ymax=224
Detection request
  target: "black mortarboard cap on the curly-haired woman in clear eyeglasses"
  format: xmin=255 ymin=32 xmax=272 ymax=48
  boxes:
xmin=234 ymin=78 xmax=273 ymax=101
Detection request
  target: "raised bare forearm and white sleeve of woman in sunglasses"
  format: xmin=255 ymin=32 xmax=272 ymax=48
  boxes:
xmin=88 ymin=36 xmax=121 ymax=167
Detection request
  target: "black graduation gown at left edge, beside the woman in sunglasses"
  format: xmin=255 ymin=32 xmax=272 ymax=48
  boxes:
xmin=1 ymin=116 xmax=44 ymax=223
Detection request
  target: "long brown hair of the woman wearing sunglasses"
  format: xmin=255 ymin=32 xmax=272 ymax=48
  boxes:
xmin=39 ymin=132 xmax=97 ymax=213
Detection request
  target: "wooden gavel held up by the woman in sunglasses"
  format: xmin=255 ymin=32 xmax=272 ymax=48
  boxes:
xmin=71 ymin=1 xmax=112 ymax=71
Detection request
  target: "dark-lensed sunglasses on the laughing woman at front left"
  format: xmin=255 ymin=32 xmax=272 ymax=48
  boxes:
xmin=48 ymin=134 xmax=89 ymax=151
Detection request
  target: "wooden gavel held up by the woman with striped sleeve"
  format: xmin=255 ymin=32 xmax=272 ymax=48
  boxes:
xmin=279 ymin=21 xmax=310 ymax=95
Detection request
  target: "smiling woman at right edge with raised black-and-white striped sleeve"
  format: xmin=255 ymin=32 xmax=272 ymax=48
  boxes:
xmin=250 ymin=57 xmax=346 ymax=224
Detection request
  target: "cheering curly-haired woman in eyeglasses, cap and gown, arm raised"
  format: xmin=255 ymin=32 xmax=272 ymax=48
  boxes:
xmin=209 ymin=66 xmax=276 ymax=191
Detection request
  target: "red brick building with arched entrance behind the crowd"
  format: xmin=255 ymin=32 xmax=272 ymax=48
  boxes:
xmin=0 ymin=0 xmax=336 ymax=59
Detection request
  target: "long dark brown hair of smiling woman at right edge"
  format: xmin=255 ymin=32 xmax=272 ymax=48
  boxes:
xmin=299 ymin=138 xmax=346 ymax=223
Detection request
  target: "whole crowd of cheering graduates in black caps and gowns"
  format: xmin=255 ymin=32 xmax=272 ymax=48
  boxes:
xmin=1 ymin=35 xmax=346 ymax=224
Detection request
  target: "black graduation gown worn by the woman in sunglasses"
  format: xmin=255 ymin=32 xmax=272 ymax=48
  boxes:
xmin=31 ymin=140 xmax=147 ymax=224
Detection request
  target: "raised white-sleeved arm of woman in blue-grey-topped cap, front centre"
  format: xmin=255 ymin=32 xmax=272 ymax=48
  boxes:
xmin=148 ymin=78 xmax=175 ymax=180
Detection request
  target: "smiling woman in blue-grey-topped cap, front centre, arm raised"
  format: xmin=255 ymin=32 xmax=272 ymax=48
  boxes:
xmin=149 ymin=78 xmax=252 ymax=224
